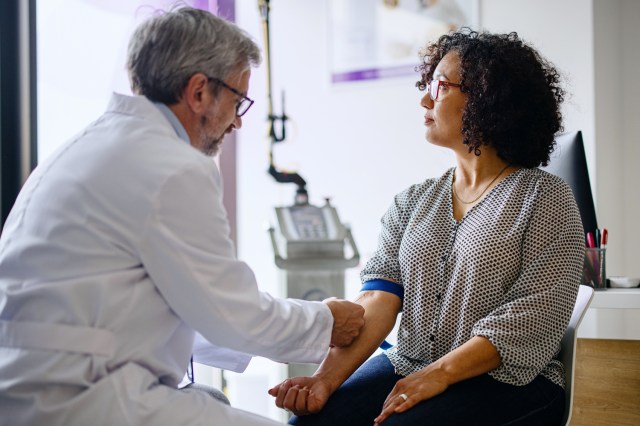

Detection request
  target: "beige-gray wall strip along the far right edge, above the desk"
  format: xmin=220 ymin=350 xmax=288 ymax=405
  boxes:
xmin=594 ymin=0 xmax=640 ymax=276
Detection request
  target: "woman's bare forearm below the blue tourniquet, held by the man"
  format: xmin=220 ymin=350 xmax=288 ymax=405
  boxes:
xmin=314 ymin=291 xmax=402 ymax=393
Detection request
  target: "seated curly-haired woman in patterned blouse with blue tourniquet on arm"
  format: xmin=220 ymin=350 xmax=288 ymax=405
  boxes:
xmin=269 ymin=29 xmax=584 ymax=426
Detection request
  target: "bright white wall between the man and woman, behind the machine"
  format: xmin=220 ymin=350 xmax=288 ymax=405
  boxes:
xmin=226 ymin=0 xmax=453 ymax=418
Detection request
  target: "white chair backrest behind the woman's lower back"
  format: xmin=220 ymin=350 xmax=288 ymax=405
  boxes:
xmin=559 ymin=285 xmax=593 ymax=425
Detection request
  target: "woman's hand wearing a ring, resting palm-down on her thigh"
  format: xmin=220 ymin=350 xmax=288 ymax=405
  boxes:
xmin=374 ymin=367 xmax=449 ymax=426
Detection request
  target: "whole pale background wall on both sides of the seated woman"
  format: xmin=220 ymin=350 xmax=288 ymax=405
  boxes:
xmin=235 ymin=0 xmax=640 ymax=418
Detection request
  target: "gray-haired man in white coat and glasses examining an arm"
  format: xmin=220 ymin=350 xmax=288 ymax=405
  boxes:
xmin=0 ymin=8 xmax=364 ymax=426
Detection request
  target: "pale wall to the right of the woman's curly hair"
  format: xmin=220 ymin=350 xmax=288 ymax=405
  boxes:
xmin=480 ymin=0 xmax=640 ymax=276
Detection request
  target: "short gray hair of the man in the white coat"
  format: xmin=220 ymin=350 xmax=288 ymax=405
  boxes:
xmin=127 ymin=7 xmax=261 ymax=105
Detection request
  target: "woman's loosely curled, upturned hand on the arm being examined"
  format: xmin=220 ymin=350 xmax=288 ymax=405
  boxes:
xmin=269 ymin=377 xmax=332 ymax=416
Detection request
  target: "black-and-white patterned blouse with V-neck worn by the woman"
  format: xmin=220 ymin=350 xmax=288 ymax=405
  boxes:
xmin=361 ymin=168 xmax=584 ymax=386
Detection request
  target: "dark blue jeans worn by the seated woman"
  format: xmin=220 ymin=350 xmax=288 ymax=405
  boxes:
xmin=289 ymin=354 xmax=565 ymax=426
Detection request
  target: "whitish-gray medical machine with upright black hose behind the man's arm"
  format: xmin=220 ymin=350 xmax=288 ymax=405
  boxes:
xmin=258 ymin=0 xmax=360 ymax=377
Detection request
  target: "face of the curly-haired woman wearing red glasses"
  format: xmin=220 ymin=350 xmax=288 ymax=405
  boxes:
xmin=420 ymin=52 xmax=467 ymax=152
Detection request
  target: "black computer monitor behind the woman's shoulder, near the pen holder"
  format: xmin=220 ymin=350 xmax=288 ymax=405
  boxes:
xmin=541 ymin=131 xmax=598 ymax=235
